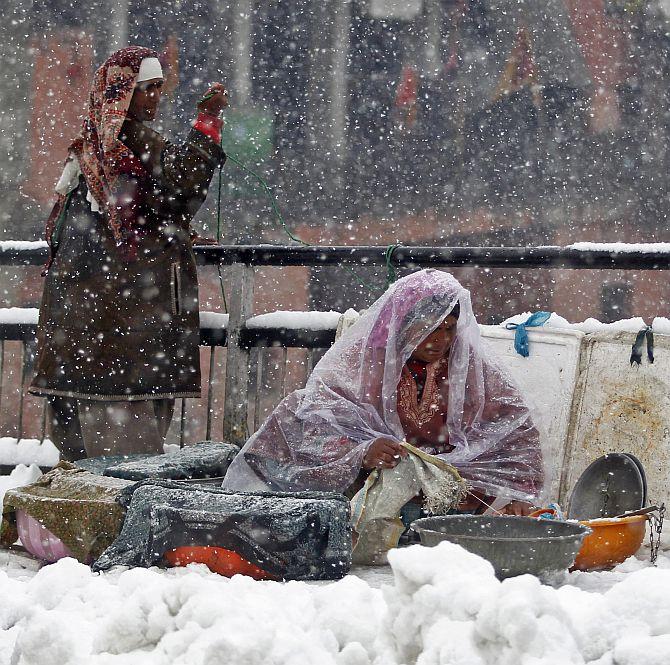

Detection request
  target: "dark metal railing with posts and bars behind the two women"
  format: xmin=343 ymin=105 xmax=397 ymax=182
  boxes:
xmin=0 ymin=243 xmax=670 ymax=444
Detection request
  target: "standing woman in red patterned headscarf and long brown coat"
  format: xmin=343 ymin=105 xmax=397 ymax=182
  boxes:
xmin=30 ymin=46 xmax=228 ymax=460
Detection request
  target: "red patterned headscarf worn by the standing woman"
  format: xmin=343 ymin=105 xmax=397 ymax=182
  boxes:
xmin=46 ymin=46 xmax=158 ymax=260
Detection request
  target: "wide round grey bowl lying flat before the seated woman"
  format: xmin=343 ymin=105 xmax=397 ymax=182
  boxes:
xmin=412 ymin=515 xmax=591 ymax=579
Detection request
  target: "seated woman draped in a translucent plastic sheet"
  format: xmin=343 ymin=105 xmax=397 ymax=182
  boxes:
xmin=223 ymin=270 xmax=543 ymax=516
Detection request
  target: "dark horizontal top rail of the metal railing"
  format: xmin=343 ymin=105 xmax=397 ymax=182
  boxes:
xmin=0 ymin=243 xmax=670 ymax=270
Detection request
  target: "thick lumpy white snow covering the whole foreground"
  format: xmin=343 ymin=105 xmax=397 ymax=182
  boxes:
xmin=0 ymin=543 xmax=670 ymax=665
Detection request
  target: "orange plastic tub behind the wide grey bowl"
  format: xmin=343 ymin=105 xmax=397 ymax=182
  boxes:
xmin=571 ymin=515 xmax=647 ymax=570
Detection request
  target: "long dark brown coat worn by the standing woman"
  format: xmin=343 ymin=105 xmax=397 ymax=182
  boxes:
xmin=30 ymin=120 xmax=225 ymax=400
